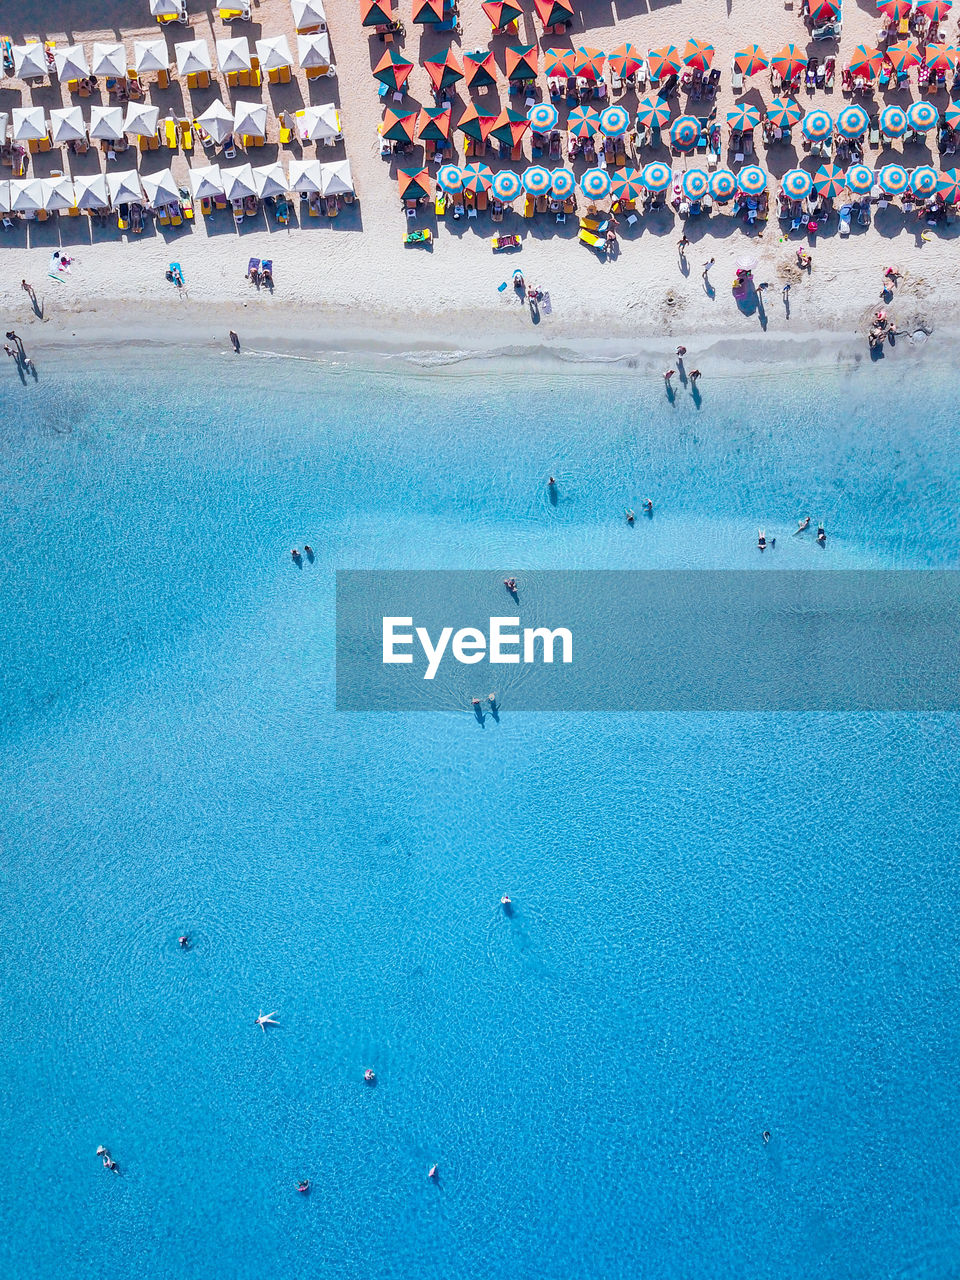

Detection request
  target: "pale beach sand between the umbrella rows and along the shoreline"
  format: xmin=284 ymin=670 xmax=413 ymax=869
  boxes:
xmin=0 ymin=0 xmax=960 ymax=351
